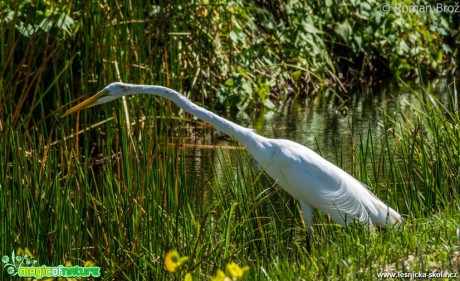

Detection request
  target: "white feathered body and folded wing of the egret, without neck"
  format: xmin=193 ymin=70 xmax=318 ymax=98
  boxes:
xmin=267 ymin=141 xmax=399 ymax=224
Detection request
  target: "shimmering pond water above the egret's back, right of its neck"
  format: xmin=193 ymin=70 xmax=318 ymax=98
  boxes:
xmin=227 ymin=87 xmax=416 ymax=167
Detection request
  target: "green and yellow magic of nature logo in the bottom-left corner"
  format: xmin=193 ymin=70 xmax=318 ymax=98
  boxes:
xmin=2 ymin=250 xmax=101 ymax=279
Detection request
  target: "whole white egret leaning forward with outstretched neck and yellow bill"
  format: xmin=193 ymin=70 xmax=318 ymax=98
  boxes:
xmin=62 ymin=82 xmax=401 ymax=232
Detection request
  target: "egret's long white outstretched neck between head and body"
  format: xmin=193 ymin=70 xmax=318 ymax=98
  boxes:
xmin=130 ymin=85 xmax=264 ymax=149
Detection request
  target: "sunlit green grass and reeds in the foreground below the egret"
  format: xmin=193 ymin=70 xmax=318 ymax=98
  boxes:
xmin=0 ymin=84 xmax=460 ymax=280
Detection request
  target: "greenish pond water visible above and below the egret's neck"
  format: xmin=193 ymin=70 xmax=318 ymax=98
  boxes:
xmin=178 ymin=83 xmax=416 ymax=189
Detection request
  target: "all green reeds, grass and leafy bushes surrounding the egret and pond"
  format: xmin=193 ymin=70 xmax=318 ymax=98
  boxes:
xmin=0 ymin=0 xmax=460 ymax=280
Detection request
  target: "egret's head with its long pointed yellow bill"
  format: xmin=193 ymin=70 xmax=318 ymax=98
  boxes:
xmin=62 ymin=82 xmax=134 ymax=117
